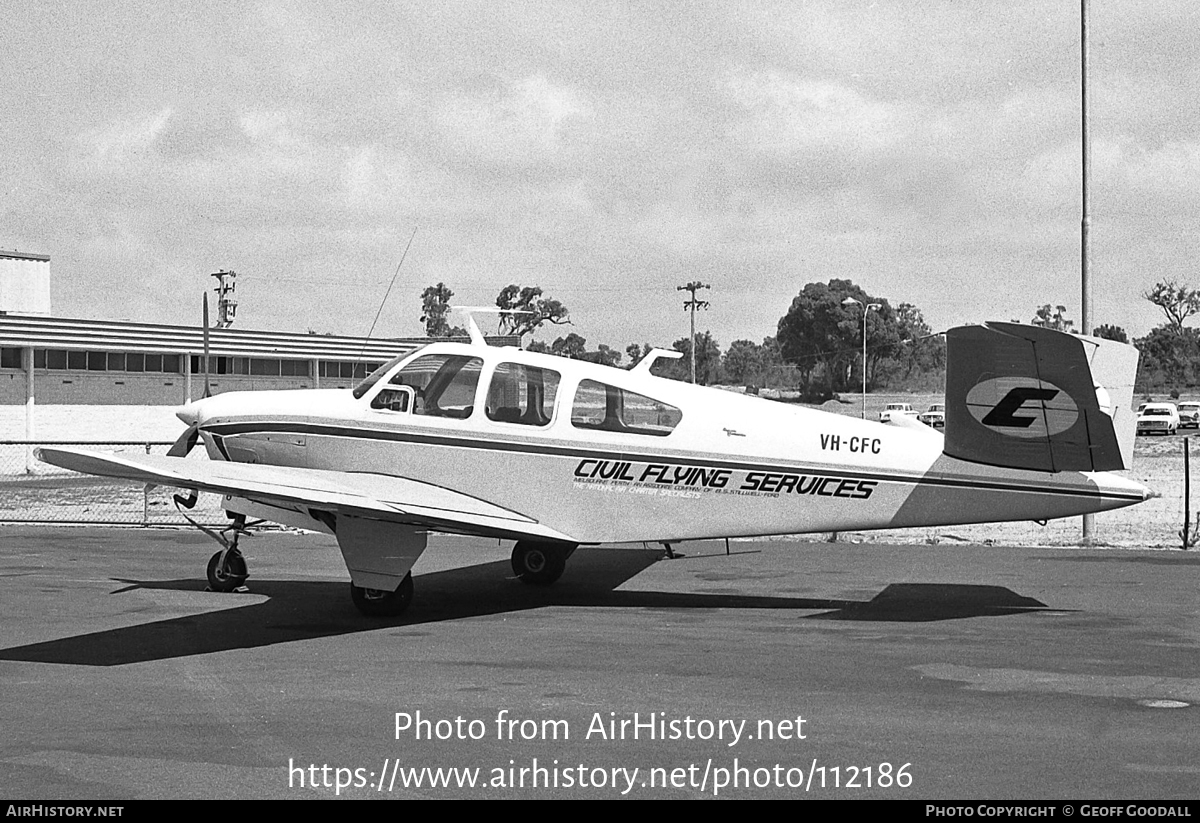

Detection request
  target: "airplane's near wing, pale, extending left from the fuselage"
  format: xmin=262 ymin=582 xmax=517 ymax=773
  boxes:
xmin=35 ymin=447 xmax=577 ymax=542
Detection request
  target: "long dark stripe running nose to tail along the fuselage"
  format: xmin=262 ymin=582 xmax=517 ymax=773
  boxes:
xmin=200 ymin=421 xmax=1144 ymax=503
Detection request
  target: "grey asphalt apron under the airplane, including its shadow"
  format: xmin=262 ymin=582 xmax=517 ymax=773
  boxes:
xmin=0 ymin=528 xmax=1200 ymax=800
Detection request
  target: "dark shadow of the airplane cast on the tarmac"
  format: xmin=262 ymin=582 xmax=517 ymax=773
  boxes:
xmin=0 ymin=551 xmax=1046 ymax=666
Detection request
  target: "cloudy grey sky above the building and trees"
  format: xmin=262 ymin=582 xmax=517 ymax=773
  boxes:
xmin=0 ymin=0 xmax=1200 ymax=350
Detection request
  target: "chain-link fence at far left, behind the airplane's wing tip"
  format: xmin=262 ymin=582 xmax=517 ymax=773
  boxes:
xmin=0 ymin=440 xmax=229 ymax=525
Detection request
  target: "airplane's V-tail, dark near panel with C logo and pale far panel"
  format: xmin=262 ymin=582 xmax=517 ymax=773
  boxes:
xmin=944 ymin=323 xmax=1138 ymax=471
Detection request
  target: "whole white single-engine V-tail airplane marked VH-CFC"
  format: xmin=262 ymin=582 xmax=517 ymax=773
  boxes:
xmin=38 ymin=314 xmax=1151 ymax=615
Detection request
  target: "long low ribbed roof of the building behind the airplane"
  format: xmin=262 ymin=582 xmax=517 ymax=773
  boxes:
xmin=0 ymin=314 xmax=521 ymax=362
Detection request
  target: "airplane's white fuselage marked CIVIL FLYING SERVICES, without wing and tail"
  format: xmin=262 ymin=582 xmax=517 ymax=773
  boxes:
xmin=194 ymin=343 xmax=1146 ymax=543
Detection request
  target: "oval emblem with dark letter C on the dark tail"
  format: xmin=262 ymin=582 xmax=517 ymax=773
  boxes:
xmin=967 ymin=376 xmax=1079 ymax=439
